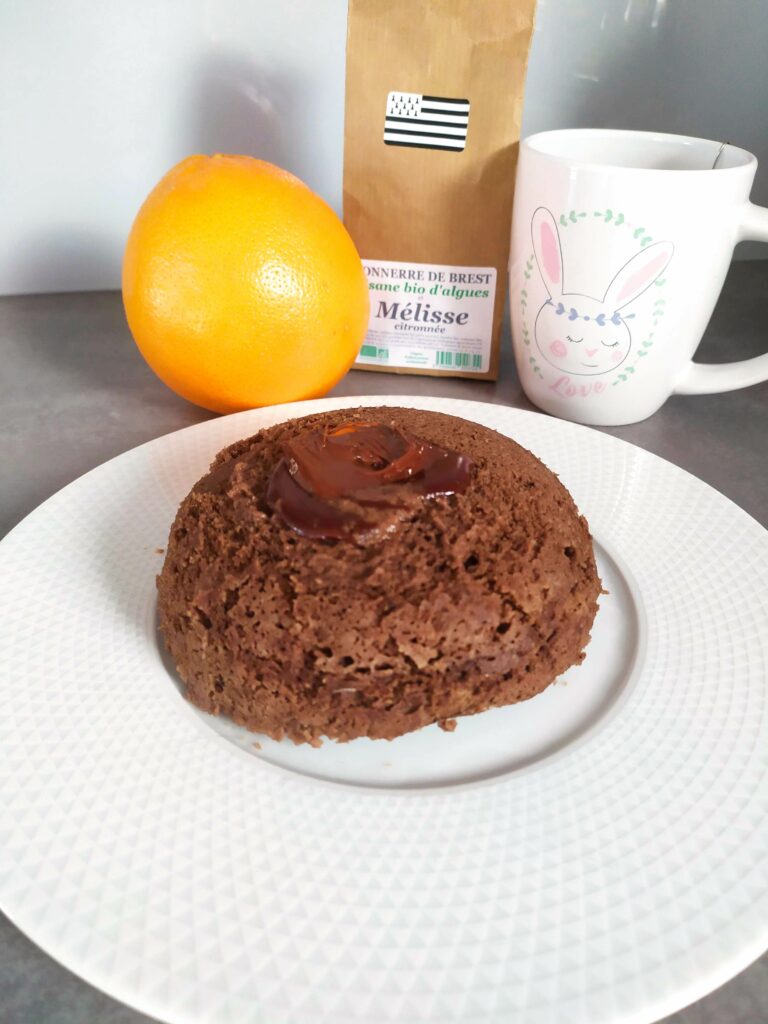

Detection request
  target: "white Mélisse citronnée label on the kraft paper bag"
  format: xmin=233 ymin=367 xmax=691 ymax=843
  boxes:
xmin=357 ymin=259 xmax=496 ymax=374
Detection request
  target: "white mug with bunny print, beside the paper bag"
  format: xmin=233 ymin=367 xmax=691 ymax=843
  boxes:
xmin=510 ymin=129 xmax=768 ymax=426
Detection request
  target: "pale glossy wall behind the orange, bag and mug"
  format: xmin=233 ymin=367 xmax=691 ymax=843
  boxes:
xmin=0 ymin=0 xmax=768 ymax=294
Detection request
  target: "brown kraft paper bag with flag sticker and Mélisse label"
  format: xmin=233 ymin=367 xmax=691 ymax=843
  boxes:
xmin=344 ymin=0 xmax=536 ymax=380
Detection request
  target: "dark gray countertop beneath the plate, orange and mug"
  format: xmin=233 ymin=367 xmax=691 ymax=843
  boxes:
xmin=0 ymin=261 xmax=768 ymax=1024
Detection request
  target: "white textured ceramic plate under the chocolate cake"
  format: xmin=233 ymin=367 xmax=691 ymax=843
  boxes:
xmin=0 ymin=396 xmax=768 ymax=1024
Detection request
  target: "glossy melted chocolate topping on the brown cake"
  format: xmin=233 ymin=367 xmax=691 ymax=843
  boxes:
xmin=266 ymin=423 xmax=474 ymax=541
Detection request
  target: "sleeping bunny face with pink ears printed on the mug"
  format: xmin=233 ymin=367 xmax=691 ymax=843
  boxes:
xmin=530 ymin=207 xmax=674 ymax=376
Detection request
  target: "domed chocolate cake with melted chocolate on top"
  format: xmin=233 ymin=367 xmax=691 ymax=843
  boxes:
xmin=158 ymin=408 xmax=600 ymax=744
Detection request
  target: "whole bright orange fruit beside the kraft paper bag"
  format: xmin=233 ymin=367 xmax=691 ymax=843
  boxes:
xmin=123 ymin=156 xmax=369 ymax=413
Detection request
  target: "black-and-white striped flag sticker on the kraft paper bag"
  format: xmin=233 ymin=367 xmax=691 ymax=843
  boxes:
xmin=384 ymin=92 xmax=469 ymax=152
